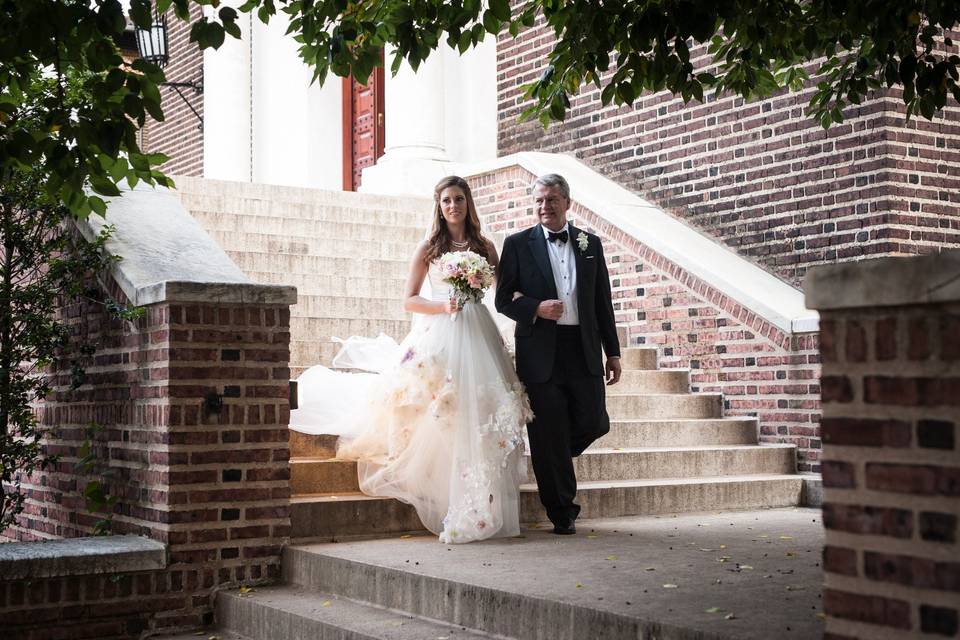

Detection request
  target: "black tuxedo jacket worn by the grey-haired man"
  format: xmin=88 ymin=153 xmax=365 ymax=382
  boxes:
xmin=496 ymin=224 xmax=620 ymax=383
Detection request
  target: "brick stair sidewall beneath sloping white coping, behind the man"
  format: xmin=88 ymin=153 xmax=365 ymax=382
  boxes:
xmin=470 ymin=167 xmax=820 ymax=471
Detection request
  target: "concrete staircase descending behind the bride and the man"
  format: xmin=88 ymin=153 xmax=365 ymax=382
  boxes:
xmin=177 ymin=178 xmax=803 ymax=544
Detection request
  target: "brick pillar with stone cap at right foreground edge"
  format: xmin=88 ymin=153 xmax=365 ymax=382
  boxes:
xmin=806 ymin=251 xmax=960 ymax=640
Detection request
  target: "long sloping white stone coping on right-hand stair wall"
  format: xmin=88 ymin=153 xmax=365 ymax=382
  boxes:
xmin=457 ymin=152 xmax=819 ymax=333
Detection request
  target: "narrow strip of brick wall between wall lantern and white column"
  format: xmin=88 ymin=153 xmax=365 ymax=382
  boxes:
xmin=141 ymin=3 xmax=203 ymax=176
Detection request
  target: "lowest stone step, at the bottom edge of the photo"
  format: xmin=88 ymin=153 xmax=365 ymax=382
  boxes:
xmin=216 ymin=585 xmax=493 ymax=640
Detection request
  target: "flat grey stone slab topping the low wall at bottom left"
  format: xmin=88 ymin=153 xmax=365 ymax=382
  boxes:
xmin=0 ymin=536 xmax=167 ymax=581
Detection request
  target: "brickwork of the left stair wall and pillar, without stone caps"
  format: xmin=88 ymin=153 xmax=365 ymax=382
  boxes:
xmin=0 ymin=278 xmax=290 ymax=638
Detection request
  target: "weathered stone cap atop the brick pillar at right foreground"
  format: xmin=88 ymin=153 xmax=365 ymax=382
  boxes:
xmin=803 ymin=249 xmax=960 ymax=310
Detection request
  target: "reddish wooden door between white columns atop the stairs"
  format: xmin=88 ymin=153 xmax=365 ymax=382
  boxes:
xmin=343 ymin=62 xmax=384 ymax=191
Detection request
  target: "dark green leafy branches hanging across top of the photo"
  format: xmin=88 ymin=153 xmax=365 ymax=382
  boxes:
xmin=0 ymin=0 xmax=960 ymax=215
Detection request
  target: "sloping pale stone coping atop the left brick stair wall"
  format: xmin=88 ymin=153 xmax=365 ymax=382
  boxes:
xmin=76 ymin=183 xmax=297 ymax=305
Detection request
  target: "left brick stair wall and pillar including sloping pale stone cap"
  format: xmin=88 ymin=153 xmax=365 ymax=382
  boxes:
xmin=0 ymin=185 xmax=296 ymax=639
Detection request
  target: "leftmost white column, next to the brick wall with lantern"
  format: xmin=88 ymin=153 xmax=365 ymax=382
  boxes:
xmin=203 ymin=8 xmax=251 ymax=182
